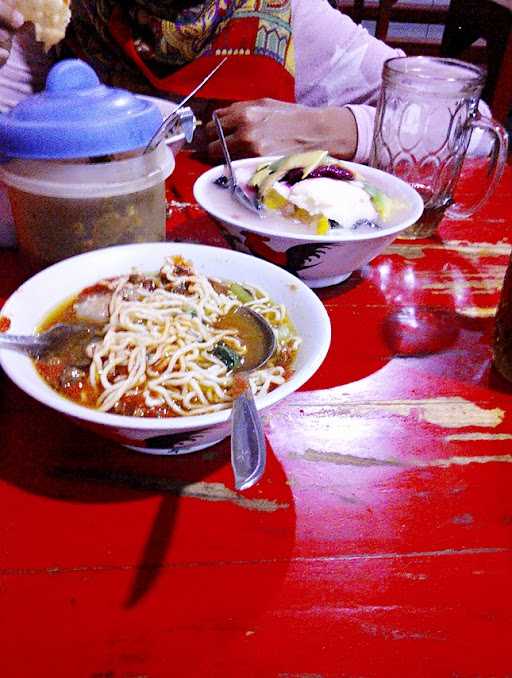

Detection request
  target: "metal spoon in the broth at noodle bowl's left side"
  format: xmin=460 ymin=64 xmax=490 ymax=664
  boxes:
xmin=0 ymin=323 xmax=97 ymax=358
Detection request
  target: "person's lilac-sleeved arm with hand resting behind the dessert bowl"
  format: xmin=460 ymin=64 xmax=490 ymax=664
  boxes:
xmin=206 ymin=0 xmax=403 ymax=162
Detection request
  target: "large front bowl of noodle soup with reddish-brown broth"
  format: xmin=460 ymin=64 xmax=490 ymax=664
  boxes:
xmin=0 ymin=243 xmax=330 ymax=454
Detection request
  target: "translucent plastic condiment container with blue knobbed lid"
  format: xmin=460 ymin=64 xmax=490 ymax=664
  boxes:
xmin=0 ymin=59 xmax=174 ymax=268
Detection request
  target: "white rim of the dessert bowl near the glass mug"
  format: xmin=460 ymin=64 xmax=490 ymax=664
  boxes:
xmin=193 ymin=155 xmax=424 ymax=244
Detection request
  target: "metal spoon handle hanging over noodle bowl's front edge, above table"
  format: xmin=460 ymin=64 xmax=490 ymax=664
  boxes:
xmin=231 ymin=375 xmax=267 ymax=490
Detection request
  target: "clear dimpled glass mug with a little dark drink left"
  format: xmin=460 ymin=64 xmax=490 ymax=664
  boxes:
xmin=370 ymin=56 xmax=508 ymax=238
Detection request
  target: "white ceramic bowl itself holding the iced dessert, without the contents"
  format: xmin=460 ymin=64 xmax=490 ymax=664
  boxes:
xmin=194 ymin=156 xmax=423 ymax=287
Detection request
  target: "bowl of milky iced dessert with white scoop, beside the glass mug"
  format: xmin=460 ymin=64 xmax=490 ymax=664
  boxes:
xmin=194 ymin=153 xmax=423 ymax=288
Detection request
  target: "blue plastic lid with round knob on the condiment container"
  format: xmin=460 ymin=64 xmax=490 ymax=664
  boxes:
xmin=0 ymin=59 xmax=162 ymax=160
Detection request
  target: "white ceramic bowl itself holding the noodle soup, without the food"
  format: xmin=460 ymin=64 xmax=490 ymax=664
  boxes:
xmin=0 ymin=243 xmax=331 ymax=454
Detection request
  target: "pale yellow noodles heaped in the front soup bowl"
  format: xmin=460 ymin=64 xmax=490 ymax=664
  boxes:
xmin=88 ymin=257 xmax=300 ymax=416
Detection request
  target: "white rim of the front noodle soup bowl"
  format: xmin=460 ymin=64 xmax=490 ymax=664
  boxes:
xmin=0 ymin=241 xmax=331 ymax=431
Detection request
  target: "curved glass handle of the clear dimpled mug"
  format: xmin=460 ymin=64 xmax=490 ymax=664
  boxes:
xmin=445 ymin=114 xmax=508 ymax=219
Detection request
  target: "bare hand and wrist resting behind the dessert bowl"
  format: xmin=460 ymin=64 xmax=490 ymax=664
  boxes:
xmin=206 ymin=99 xmax=357 ymax=160
